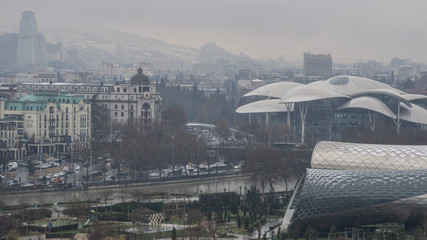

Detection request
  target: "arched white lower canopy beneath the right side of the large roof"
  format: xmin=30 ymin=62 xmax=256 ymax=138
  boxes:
xmin=338 ymin=96 xmax=396 ymax=119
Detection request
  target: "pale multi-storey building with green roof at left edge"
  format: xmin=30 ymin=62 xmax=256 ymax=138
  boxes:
xmin=0 ymin=91 xmax=91 ymax=153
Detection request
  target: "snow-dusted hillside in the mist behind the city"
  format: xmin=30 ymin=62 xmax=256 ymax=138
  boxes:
xmin=44 ymin=26 xmax=249 ymax=68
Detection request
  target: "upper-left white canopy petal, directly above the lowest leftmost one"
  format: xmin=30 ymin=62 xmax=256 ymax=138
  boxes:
xmin=243 ymin=82 xmax=304 ymax=98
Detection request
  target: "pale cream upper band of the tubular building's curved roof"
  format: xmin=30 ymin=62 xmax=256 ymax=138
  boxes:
xmin=311 ymin=141 xmax=427 ymax=170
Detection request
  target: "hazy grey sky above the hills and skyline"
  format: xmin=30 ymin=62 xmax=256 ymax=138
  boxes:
xmin=0 ymin=0 xmax=427 ymax=64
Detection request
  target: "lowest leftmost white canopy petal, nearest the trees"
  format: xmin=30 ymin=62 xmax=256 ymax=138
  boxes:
xmin=236 ymin=99 xmax=294 ymax=113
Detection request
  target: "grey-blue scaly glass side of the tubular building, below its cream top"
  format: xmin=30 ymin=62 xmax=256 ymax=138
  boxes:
xmin=293 ymin=169 xmax=427 ymax=221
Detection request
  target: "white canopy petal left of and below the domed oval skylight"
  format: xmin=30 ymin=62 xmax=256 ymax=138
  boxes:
xmin=280 ymin=85 xmax=350 ymax=103
